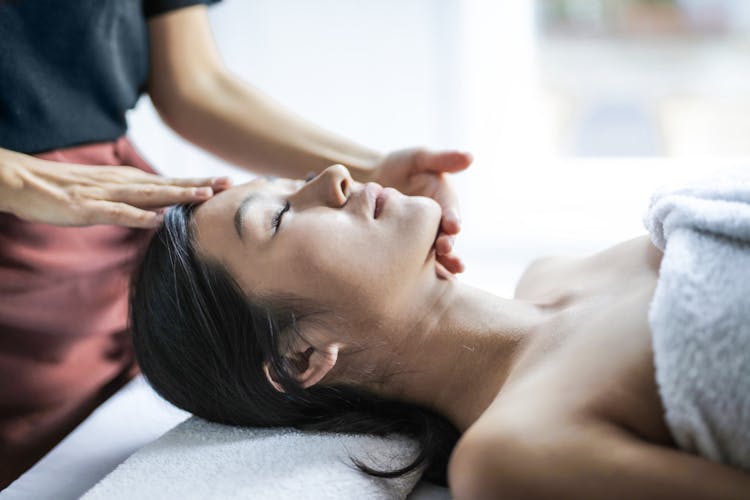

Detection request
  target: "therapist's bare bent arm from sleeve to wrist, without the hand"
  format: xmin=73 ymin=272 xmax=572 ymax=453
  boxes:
xmin=148 ymin=6 xmax=384 ymax=180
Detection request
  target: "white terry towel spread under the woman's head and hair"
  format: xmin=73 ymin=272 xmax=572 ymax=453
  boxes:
xmin=82 ymin=417 xmax=421 ymax=500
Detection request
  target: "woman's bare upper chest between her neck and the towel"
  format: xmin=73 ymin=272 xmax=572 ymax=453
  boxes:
xmin=483 ymin=239 xmax=670 ymax=443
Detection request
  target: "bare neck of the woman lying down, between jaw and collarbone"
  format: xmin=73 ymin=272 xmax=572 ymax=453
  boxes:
xmin=362 ymin=280 xmax=544 ymax=432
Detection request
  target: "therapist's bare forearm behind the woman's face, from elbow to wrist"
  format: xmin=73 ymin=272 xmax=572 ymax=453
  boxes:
xmin=155 ymin=72 xmax=382 ymax=181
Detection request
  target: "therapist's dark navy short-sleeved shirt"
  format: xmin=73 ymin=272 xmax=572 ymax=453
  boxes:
xmin=0 ymin=0 xmax=218 ymax=153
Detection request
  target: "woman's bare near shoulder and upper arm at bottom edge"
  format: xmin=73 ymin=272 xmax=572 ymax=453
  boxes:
xmin=448 ymin=406 xmax=750 ymax=500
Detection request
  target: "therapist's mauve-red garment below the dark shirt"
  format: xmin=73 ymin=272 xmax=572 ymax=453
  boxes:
xmin=0 ymin=137 xmax=156 ymax=489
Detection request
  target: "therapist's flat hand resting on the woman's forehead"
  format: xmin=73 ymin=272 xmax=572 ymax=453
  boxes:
xmin=0 ymin=150 xmax=231 ymax=228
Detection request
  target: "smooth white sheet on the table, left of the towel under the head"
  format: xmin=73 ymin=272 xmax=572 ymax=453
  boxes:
xmin=0 ymin=377 xmax=450 ymax=500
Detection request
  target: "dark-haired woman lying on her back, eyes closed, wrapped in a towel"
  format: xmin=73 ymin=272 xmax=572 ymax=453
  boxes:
xmin=131 ymin=165 xmax=750 ymax=500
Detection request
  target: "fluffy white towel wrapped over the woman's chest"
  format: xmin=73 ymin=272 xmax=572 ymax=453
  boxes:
xmin=644 ymin=169 xmax=750 ymax=470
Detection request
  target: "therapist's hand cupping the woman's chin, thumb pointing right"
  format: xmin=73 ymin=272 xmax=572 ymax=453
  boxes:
xmin=372 ymin=149 xmax=472 ymax=278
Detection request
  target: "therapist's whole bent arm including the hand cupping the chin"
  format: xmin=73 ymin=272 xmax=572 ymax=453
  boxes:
xmin=148 ymin=5 xmax=472 ymax=278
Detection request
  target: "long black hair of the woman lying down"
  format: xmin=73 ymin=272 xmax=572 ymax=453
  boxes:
xmin=130 ymin=205 xmax=459 ymax=485
